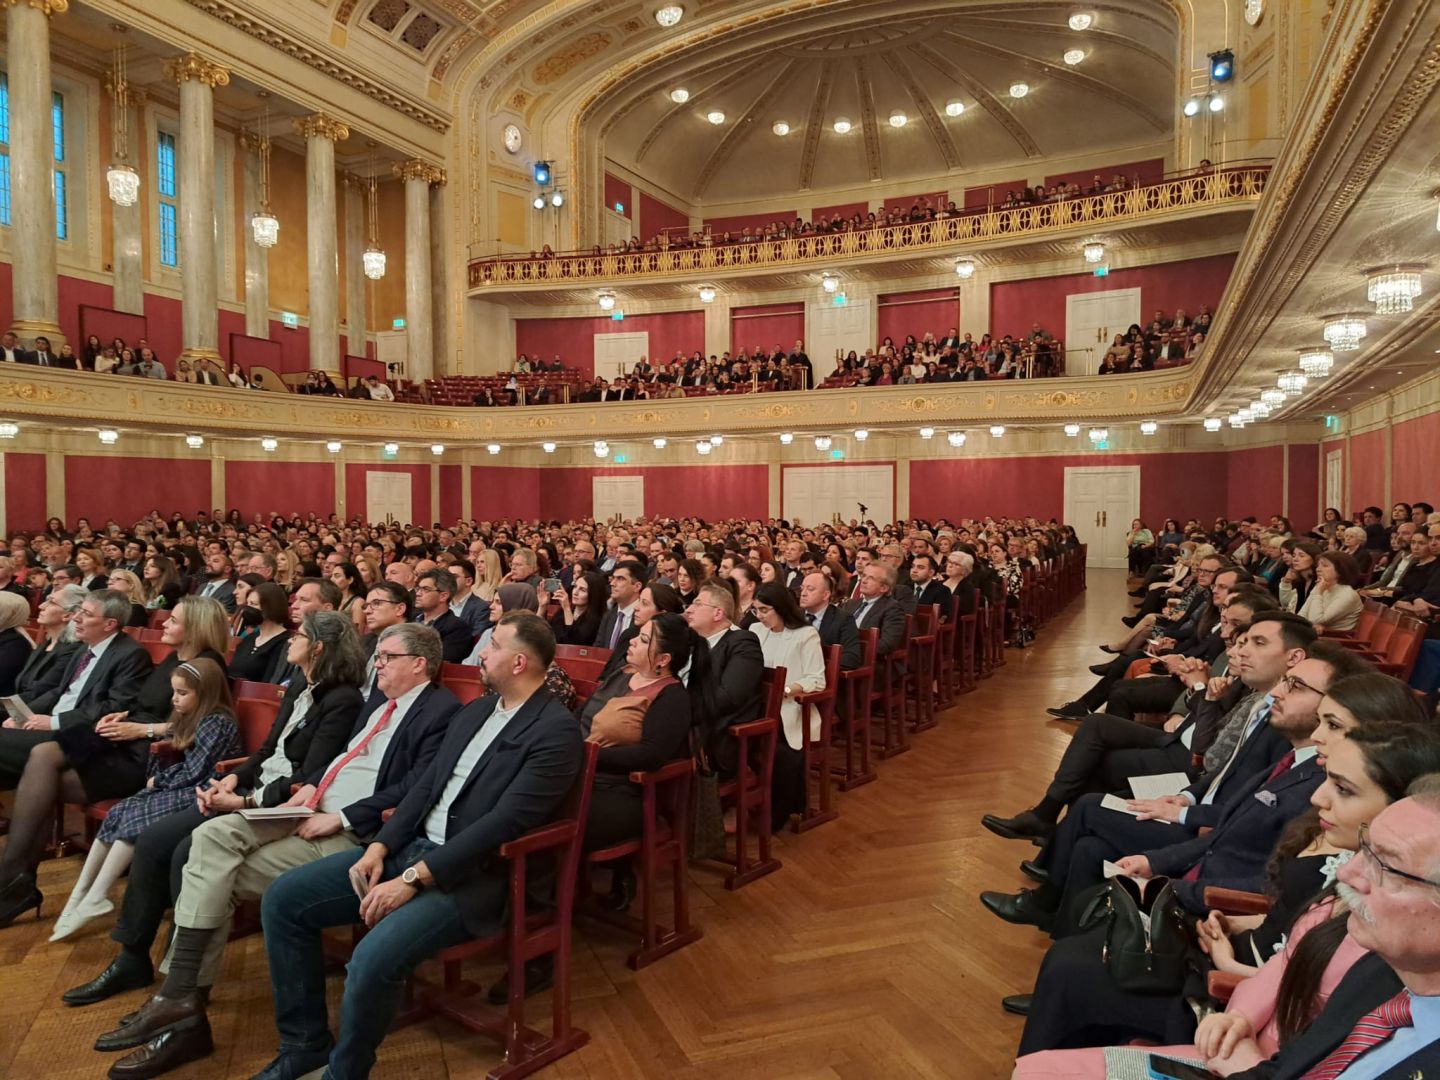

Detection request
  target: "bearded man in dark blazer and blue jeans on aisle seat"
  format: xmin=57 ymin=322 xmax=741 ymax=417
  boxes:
xmin=249 ymin=612 xmax=583 ymax=1076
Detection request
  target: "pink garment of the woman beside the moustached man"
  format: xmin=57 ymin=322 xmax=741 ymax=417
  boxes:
xmin=1012 ymin=900 xmax=1367 ymax=1080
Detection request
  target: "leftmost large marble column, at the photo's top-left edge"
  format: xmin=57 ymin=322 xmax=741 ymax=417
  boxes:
xmin=0 ymin=0 xmax=67 ymax=348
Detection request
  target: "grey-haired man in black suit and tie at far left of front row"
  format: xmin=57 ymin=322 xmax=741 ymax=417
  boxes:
xmin=0 ymin=589 xmax=154 ymax=791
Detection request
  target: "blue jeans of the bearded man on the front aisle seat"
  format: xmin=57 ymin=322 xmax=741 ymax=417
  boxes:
xmin=261 ymin=840 xmax=471 ymax=1080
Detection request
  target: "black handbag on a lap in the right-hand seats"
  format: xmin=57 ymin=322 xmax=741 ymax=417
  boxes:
xmin=1080 ymin=877 xmax=1194 ymax=994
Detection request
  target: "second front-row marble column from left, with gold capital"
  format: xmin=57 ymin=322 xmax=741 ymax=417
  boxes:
xmin=166 ymin=52 xmax=230 ymax=364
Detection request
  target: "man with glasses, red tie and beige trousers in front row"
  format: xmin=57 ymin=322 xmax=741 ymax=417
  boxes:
xmin=102 ymin=624 xmax=459 ymax=1077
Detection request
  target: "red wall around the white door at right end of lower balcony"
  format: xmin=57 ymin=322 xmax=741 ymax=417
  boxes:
xmin=989 ymin=255 xmax=1236 ymax=338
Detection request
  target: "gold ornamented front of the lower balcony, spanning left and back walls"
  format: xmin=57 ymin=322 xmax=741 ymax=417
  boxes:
xmin=0 ymin=367 xmax=1192 ymax=448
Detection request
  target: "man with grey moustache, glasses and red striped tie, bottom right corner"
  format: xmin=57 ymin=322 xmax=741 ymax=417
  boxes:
xmin=1210 ymin=776 xmax=1440 ymax=1080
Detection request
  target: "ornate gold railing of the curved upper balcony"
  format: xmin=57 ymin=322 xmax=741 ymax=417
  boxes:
xmin=469 ymin=166 xmax=1270 ymax=291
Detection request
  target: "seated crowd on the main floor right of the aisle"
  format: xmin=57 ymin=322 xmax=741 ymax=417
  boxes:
xmin=979 ymin=504 xmax=1440 ymax=1080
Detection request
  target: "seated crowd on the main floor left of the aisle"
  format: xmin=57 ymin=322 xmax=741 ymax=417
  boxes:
xmin=0 ymin=510 xmax=1079 ymax=1079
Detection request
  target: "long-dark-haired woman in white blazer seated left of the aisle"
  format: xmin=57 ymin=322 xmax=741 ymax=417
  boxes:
xmin=750 ymin=582 xmax=825 ymax=829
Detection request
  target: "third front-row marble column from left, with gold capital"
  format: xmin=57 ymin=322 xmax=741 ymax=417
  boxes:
xmin=295 ymin=112 xmax=350 ymax=372
